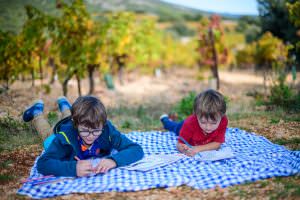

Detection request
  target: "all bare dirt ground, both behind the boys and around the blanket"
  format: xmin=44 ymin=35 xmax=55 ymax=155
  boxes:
xmin=0 ymin=69 xmax=300 ymax=199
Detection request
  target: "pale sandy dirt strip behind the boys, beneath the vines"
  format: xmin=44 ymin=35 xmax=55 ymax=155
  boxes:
xmin=0 ymin=69 xmax=263 ymax=116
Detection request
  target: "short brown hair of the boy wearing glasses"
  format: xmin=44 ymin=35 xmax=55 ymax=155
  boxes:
xmin=71 ymin=96 xmax=107 ymax=129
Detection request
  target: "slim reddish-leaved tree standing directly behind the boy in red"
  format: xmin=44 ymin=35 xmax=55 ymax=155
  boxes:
xmin=198 ymin=15 xmax=227 ymax=89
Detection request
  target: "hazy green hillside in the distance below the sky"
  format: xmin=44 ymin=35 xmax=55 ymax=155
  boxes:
xmin=0 ymin=0 xmax=243 ymax=32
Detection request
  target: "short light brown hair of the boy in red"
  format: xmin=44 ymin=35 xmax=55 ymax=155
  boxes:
xmin=194 ymin=89 xmax=226 ymax=120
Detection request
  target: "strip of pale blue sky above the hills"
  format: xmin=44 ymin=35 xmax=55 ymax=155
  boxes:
xmin=163 ymin=0 xmax=258 ymax=15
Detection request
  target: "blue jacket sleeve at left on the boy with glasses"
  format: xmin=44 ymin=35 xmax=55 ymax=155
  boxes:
xmin=37 ymin=136 xmax=76 ymax=176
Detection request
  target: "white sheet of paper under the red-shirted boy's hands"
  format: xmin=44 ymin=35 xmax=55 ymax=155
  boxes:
xmin=194 ymin=147 xmax=235 ymax=161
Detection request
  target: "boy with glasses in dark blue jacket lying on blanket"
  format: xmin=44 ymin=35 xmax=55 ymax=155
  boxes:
xmin=23 ymin=96 xmax=144 ymax=177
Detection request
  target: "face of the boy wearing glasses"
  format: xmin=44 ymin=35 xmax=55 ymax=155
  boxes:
xmin=78 ymin=125 xmax=102 ymax=145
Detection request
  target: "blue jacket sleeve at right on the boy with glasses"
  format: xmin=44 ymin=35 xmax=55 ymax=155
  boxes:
xmin=108 ymin=123 xmax=144 ymax=167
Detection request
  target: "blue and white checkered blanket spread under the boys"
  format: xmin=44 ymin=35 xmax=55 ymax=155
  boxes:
xmin=18 ymin=128 xmax=300 ymax=198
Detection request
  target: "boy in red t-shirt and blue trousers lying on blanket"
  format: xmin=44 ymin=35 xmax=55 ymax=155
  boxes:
xmin=160 ymin=89 xmax=228 ymax=156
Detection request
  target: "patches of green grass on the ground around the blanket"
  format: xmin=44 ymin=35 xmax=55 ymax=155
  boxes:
xmin=0 ymin=99 xmax=300 ymax=199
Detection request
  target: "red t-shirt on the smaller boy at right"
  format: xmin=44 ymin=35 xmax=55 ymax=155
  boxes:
xmin=178 ymin=114 xmax=228 ymax=146
